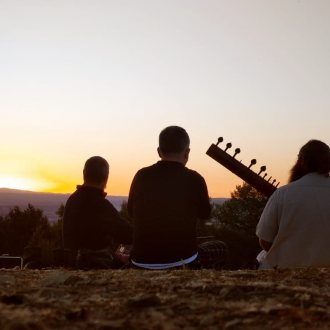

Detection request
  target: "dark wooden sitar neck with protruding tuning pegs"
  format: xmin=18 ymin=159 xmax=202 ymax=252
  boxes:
xmin=206 ymin=137 xmax=280 ymax=197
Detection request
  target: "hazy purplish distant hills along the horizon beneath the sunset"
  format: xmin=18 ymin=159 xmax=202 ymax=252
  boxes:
xmin=0 ymin=188 xmax=227 ymax=222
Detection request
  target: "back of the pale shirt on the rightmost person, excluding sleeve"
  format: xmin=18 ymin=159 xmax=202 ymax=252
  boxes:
xmin=263 ymin=173 xmax=330 ymax=268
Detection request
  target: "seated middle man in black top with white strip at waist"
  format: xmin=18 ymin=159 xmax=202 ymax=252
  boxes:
xmin=127 ymin=126 xmax=225 ymax=269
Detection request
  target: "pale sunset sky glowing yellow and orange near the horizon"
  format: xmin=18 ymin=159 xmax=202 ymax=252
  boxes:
xmin=0 ymin=0 xmax=330 ymax=198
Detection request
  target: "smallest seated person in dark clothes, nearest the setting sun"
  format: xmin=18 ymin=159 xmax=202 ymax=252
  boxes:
xmin=63 ymin=156 xmax=132 ymax=269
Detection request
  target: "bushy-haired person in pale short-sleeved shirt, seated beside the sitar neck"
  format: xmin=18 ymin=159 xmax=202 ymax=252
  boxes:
xmin=256 ymin=140 xmax=330 ymax=269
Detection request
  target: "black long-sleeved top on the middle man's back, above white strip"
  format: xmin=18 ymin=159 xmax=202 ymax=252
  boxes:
xmin=129 ymin=161 xmax=210 ymax=263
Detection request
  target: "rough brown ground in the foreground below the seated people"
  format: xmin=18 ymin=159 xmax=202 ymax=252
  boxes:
xmin=0 ymin=269 xmax=330 ymax=330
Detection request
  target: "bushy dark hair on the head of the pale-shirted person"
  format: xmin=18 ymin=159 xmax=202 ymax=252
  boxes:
xmin=289 ymin=140 xmax=330 ymax=182
